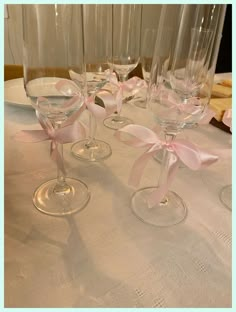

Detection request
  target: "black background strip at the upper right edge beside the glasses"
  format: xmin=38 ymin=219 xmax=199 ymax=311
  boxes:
xmin=215 ymin=4 xmax=232 ymax=73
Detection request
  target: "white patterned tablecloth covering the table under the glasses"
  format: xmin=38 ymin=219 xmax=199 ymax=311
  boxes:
xmin=5 ymin=100 xmax=231 ymax=307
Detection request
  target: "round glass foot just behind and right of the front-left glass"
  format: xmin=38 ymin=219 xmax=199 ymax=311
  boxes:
xmin=71 ymin=140 xmax=112 ymax=161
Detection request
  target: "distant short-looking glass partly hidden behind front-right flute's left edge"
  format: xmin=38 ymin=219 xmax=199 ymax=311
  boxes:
xmin=134 ymin=28 xmax=157 ymax=108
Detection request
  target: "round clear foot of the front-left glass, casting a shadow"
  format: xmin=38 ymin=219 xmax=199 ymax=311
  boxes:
xmin=33 ymin=178 xmax=90 ymax=217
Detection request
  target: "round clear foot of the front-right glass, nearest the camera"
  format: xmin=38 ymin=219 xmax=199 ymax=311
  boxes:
xmin=131 ymin=187 xmax=187 ymax=227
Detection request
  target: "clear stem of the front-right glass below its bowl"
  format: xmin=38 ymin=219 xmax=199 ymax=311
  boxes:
xmin=158 ymin=133 xmax=176 ymax=204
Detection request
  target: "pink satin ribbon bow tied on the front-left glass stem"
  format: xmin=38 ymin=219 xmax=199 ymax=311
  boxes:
xmin=15 ymin=103 xmax=85 ymax=174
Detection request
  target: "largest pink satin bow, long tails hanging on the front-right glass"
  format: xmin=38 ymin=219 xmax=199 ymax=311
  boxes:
xmin=115 ymin=125 xmax=218 ymax=207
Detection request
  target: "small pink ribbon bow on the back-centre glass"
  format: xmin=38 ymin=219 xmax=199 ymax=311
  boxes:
xmin=109 ymin=73 xmax=146 ymax=113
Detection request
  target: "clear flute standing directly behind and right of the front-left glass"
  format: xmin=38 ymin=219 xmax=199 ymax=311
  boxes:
xmin=71 ymin=4 xmax=112 ymax=161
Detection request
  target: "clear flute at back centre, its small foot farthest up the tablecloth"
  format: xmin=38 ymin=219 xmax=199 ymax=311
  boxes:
xmin=104 ymin=4 xmax=142 ymax=129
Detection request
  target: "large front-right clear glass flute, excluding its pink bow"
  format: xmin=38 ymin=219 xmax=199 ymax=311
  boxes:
xmin=131 ymin=4 xmax=225 ymax=226
